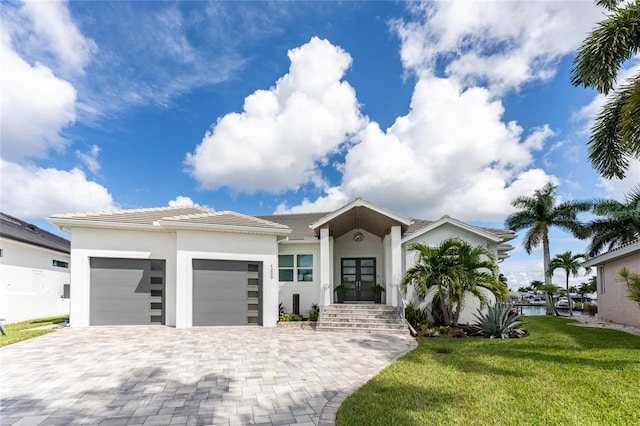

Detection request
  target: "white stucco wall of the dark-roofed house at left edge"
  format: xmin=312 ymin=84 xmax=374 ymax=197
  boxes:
xmin=0 ymin=238 xmax=70 ymax=322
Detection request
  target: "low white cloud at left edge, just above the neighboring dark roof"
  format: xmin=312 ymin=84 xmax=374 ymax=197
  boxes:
xmin=0 ymin=160 xmax=115 ymax=219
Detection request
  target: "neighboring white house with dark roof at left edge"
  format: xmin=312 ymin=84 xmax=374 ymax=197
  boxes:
xmin=0 ymin=213 xmax=70 ymax=322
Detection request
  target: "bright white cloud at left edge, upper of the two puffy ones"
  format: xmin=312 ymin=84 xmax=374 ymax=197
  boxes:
xmin=0 ymin=41 xmax=76 ymax=160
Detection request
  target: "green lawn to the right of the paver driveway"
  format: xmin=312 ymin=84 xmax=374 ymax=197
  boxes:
xmin=337 ymin=316 xmax=640 ymax=426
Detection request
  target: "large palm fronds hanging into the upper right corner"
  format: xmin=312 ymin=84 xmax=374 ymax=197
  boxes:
xmin=571 ymin=0 xmax=640 ymax=179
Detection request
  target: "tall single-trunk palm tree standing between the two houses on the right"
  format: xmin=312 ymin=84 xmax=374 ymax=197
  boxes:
xmin=505 ymin=183 xmax=592 ymax=306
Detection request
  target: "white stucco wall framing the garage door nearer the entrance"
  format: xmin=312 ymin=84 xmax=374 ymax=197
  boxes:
xmin=175 ymin=230 xmax=278 ymax=328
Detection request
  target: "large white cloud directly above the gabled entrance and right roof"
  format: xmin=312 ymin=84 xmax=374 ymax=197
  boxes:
xmin=279 ymin=78 xmax=555 ymax=221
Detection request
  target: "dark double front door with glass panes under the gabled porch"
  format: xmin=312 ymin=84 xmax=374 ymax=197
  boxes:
xmin=341 ymin=257 xmax=376 ymax=302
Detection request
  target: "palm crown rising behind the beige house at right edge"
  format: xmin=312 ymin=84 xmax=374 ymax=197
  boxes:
xmin=587 ymin=185 xmax=640 ymax=256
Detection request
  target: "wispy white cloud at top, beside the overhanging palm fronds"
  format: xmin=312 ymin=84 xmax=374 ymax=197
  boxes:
xmin=394 ymin=1 xmax=602 ymax=93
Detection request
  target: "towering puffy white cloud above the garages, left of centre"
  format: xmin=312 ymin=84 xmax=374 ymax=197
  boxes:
xmin=185 ymin=37 xmax=364 ymax=193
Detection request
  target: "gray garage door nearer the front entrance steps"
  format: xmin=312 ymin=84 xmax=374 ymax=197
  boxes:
xmin=193 ymin=259 xmax=262 ymax=325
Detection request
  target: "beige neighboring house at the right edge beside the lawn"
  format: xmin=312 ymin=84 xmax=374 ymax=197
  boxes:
xmin=582 ymin=240 xmax=640 ymax=327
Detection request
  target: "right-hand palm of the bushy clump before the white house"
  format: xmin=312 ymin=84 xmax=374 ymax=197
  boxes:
xmin=449 ymin=240 xmax=509 ymax=325
